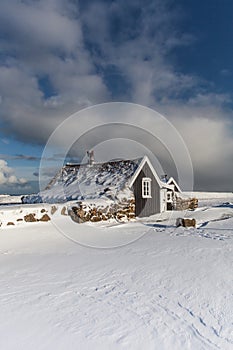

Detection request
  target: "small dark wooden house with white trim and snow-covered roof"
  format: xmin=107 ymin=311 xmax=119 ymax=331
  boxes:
xmin=24 ymin=152 xmax=181 ymax=217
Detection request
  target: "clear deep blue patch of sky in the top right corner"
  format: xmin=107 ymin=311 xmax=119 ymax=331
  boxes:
xmin=178 ymin=0 xmax=233 ymax=93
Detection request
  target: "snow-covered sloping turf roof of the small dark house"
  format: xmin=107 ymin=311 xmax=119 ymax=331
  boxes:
xmin=23 ymin=158 xmax=141 ymax=203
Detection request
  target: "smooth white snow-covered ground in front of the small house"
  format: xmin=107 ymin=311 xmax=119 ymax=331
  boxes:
xmin=0 ymin=197 xmax=233 ymax=350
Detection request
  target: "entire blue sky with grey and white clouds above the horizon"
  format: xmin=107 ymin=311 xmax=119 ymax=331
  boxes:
xmin=0 ymin=0 xmax=233 ymax=194
